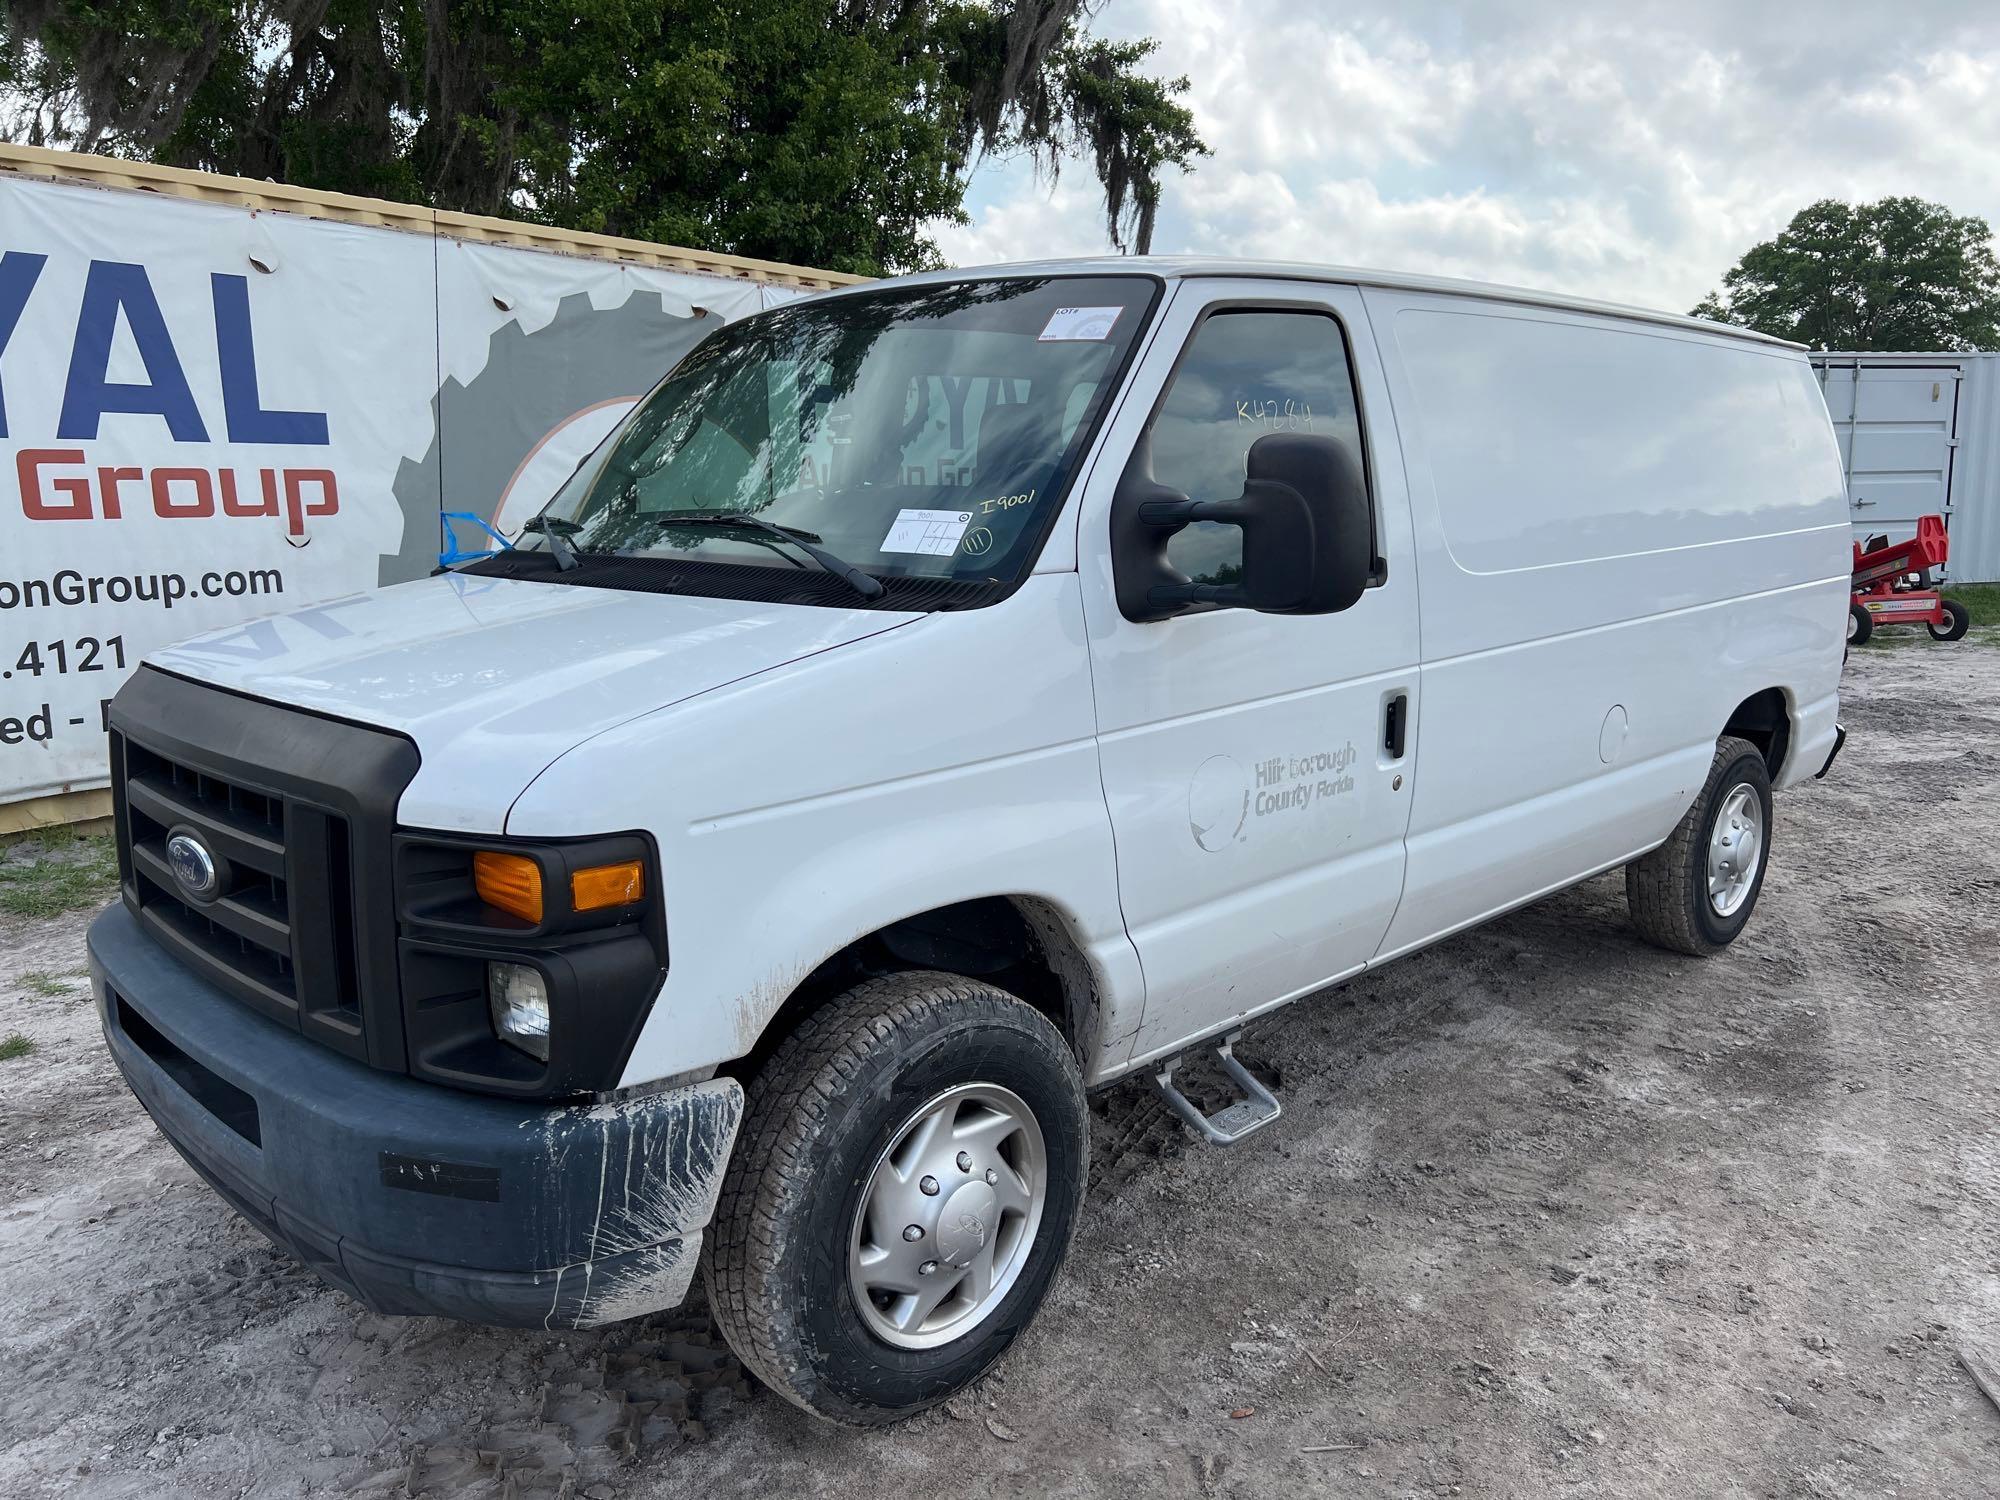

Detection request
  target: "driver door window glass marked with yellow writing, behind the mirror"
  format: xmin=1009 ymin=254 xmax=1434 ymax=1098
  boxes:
xmin=1152 ymin=308 xmax=1362 ymax=584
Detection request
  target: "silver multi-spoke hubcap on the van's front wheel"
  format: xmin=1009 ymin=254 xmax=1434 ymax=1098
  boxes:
xmin=848 ymin=1084 xmax=1048 ymax=1348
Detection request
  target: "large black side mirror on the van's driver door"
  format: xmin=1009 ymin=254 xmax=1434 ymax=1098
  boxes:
xmin=1112 ymin=432 xmax=1374 ymax=622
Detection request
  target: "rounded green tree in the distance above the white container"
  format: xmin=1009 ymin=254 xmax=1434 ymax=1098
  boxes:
xmin=1694 ymin=198 xmax=2000 ymax=350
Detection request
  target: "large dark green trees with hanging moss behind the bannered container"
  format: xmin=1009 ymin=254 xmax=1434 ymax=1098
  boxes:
xmin=0 ymin=0 xmax=1208 ymax=274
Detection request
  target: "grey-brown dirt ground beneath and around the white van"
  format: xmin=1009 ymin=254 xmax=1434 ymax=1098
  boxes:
xmin=0 ymin=642 xmax=2000 ymax=1500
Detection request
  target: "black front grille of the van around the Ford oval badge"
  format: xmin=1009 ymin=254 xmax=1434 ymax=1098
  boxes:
xmin=112 ymin=670 xmax=416 ymax=1068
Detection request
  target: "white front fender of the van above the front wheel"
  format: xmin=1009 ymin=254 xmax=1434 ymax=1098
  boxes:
xmin=506 ymin=574 xmax=1144 ymax=1086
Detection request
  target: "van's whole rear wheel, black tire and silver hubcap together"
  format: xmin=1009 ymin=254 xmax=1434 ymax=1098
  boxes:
xmin=1626 ymin=736 xmax=1772 ymax=958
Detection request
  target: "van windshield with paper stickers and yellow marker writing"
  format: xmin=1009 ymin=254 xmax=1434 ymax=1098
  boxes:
xmin=524 ymin=276 xmax=1158 ymax=602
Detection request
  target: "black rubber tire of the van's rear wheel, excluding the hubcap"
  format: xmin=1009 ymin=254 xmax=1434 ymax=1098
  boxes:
xmin=1626 ymin=734 xmax=1772 ymax=958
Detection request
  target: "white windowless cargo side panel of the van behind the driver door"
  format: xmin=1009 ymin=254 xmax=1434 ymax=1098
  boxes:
xmin=1368 ymin=290 xmax=1848 ymax=958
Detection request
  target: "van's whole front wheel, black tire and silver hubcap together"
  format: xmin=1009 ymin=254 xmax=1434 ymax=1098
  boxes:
xmin=706 ymin=972 xmax=1088 ymax=1426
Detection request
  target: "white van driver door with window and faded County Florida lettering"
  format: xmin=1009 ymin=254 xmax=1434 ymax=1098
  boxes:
xmin=1078 ymin=278 xmax=1418 ymax=1066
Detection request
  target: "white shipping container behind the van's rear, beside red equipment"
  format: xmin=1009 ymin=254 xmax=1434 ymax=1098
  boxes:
xmin=1812 ymin=352 xmax=2000 ymax=584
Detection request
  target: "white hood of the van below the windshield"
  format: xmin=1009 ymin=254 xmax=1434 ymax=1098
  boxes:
xmin=146 ymin=574 xmax=922 ymax=832
